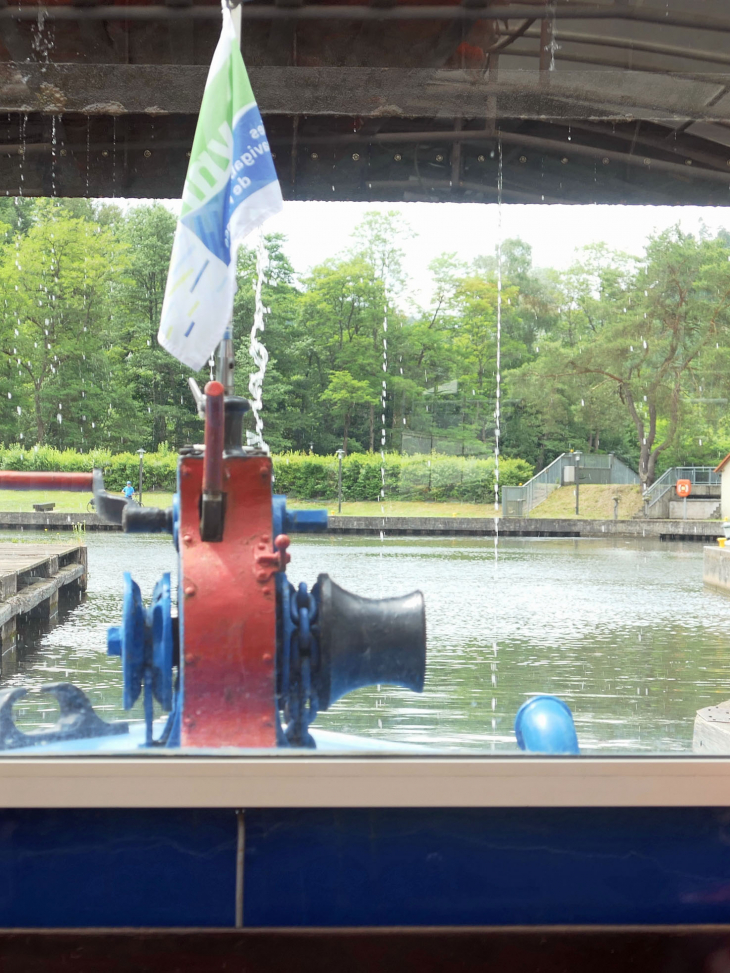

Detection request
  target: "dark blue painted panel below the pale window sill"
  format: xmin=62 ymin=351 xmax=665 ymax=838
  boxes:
xmin=0 ymin=808 xmax=730 ymax=929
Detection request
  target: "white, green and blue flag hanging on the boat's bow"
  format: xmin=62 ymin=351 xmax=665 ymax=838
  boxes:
xmin=157 ymin=0 xmax=283 ymax=371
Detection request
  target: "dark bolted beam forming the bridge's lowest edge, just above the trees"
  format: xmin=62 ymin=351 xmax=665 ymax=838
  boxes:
xmin=0 ymin=123 xmax=716 ymax=205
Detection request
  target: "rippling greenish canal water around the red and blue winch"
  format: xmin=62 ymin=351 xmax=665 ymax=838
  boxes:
xmin=0 ymin=533 xmax=730 ymax=754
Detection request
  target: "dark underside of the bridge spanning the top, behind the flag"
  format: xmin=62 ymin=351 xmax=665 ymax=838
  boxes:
xmin=0 ymin=0 xmax=730 ymax=205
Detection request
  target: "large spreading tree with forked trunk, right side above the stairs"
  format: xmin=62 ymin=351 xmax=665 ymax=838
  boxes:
xmin=513 ymin=227 xmax=730 ymax=486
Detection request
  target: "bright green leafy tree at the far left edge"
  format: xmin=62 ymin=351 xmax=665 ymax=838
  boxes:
xmin=0 ymin=207 xmax=136 ymax=448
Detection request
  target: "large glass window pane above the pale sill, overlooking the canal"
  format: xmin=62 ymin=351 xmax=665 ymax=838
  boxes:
xmin=0 ymin=3 xmax=730 ymax=756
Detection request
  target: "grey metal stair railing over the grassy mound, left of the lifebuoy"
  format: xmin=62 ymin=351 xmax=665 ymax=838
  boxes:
xmin=502 ymin=453 xmax=639 ymax=517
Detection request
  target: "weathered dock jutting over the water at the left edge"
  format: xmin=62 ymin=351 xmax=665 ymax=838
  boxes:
xmin=0 ymin=543 xmax=88 ymax=670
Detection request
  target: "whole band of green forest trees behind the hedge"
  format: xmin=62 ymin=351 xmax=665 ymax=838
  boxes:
xmin=0 ymin=198 xmax=730 ymax=484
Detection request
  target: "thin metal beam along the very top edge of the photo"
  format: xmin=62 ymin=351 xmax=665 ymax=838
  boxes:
xmin=0 ymin=3 xmax=730 ymax=32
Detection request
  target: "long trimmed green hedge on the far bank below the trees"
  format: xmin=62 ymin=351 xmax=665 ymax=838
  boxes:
xmin=0 ymin=446 xmax=533 ymax=503
